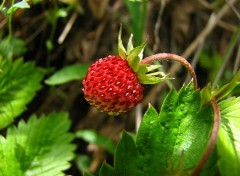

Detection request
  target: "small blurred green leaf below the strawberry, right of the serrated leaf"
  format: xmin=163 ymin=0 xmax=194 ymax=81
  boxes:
xmin=75 ymin=130 xmax=116 ymax=154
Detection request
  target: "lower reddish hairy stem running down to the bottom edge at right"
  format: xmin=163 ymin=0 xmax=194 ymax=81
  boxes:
xmin=192 ymin=99 xmax=221 ymax=176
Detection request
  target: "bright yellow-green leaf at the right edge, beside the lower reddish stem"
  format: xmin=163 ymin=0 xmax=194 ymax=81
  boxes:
xmin=217 ymin=97 xmax=240 ymax=176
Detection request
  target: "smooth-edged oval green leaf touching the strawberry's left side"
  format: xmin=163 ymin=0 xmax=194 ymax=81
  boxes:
xmin=45 ymin=64 xmax=89 ymax=86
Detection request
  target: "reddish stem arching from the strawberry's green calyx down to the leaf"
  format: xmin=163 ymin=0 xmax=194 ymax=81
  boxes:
xmin=140 ymin=53 xmax=198 ymax=90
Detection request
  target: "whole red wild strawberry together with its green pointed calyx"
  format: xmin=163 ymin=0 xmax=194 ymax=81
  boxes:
xmin=83 ymin=29 xmax=167 ymax=115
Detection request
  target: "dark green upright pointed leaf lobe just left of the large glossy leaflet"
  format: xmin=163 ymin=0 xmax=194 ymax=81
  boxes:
xmin=136 ymin=106 xmax=165 ymax=175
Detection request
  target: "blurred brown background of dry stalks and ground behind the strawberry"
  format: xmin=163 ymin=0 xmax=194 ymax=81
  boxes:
xmin=0 ymin=0 xmax=240 ymax=175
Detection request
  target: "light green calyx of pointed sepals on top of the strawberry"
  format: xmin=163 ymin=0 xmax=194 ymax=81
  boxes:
xmin=118 ymin=27 xmax=167 ymax=84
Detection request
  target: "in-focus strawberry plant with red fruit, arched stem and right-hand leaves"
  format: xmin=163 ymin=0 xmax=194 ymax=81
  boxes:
xmin=83 ymin=30 xmax=240 ymax=176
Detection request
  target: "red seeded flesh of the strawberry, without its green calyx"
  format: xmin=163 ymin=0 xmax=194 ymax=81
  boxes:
xmin=83 ymin=56 xmax=143 ymax=115
